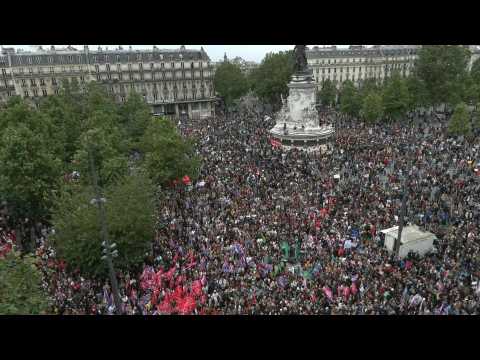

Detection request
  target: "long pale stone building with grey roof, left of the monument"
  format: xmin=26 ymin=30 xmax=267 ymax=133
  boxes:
xmin=0 ymin=46 xmax=215 ymax=118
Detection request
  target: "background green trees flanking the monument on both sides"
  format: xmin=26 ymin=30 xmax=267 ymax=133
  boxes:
xmin=215 ymin=45 xmax=480 ymax=133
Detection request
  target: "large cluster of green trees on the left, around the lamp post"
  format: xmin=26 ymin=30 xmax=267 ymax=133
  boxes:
xmin=0 ymin=83 xmax=200 ymax=313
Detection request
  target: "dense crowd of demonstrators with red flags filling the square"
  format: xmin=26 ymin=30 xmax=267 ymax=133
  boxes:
xmin=2 ymin=102 xmax=480 ymax=314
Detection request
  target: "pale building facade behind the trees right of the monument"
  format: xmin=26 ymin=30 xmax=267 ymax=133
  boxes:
xmin=307 ymin=45 xmax=419 ymax=90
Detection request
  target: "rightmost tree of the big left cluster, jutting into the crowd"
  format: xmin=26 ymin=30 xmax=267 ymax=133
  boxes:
xmin=142 ymin=118 xmax=200 ymax=185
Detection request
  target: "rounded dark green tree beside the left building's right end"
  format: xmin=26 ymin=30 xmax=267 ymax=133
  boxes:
xmin=213 ymin=62 xmax=249 ymax=106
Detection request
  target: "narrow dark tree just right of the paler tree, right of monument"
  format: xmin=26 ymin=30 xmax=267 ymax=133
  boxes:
xmin=383 ymin=72 xmax=410 ymax=120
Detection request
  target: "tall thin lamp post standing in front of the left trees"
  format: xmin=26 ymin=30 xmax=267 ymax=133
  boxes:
xmin=88 ymin=148 xmax=123 ymax=315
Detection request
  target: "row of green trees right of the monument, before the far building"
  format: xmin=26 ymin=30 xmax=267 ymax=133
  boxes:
xmin=319 ymin=45 xmax=480 ymax=135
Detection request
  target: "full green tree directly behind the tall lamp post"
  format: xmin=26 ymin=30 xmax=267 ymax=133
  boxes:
xmin=49 ymin=172 xmax=154 ymax=277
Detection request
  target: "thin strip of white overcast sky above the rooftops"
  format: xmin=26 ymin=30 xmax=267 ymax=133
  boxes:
xmin=3 ymin=45 xmax=348 ymax=62
